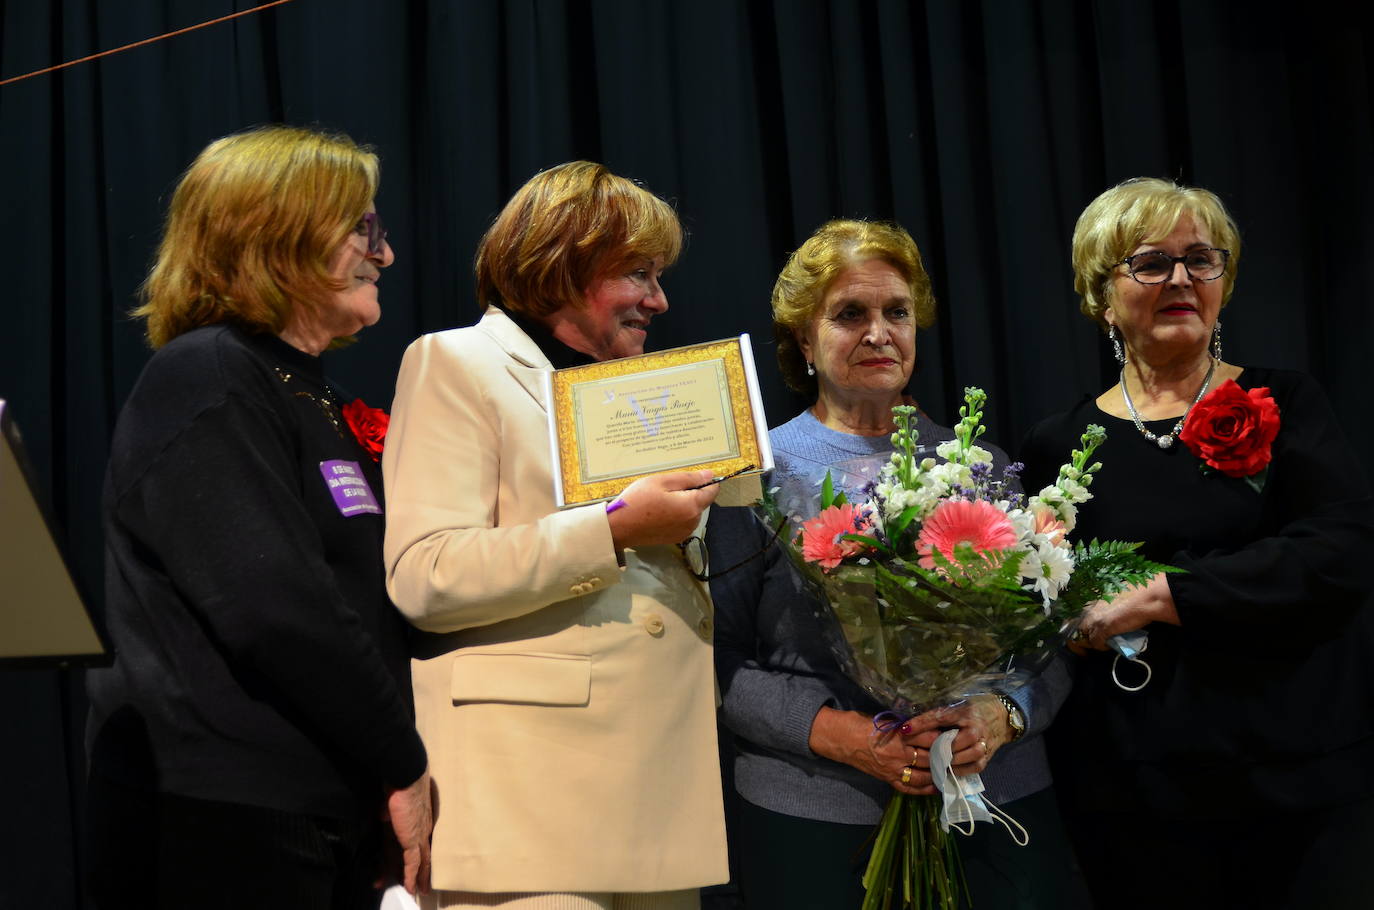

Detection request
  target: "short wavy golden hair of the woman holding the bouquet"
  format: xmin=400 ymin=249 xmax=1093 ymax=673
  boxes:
xmin=772 ymin=220 xmax=936 ymax=395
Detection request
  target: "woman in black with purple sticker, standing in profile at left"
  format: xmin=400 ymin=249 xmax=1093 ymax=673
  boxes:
xmin=88 ymin=126 xmax=430 ymax=909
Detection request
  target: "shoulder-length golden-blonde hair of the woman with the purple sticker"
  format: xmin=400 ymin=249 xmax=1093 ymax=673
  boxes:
xmin=133 ymin=126 xmax=379 ymax=348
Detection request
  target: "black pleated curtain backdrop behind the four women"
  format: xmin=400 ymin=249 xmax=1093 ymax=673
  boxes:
xmin=0 ymin=0 xmax=1374 ymax=907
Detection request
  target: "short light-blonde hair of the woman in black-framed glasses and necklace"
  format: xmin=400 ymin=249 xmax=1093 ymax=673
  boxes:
xmin=1073 ymin=177 xmax=1241 ymax=331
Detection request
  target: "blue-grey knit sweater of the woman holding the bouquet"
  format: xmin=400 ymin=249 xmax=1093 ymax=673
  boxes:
xmin=706 ymin=411 xmax=1069 ymax=825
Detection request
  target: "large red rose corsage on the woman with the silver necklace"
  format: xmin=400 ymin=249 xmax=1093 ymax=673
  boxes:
xmin=1179 ymin=379 xmax=1279 ymax=491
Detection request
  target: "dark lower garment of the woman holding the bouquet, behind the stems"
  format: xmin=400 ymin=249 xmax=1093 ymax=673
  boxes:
xmin=731 ymin=788 xmax=1087 ymax=910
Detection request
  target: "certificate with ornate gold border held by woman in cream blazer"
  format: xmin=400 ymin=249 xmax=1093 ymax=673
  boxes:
xmin=545 ymin=334 xmax=772 ymax=507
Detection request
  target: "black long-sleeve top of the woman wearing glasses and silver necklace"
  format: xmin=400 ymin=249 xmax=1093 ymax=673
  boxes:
xmin=1021 ymin=368 xmax=1374 ymax=818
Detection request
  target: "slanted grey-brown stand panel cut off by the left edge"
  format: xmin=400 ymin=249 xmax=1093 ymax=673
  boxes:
xmin=0 ymin=399 xmax=110 ymax=669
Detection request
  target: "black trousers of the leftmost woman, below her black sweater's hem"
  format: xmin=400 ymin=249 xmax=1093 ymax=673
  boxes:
xmin=87 ymin=775 xmax=381 ymax=910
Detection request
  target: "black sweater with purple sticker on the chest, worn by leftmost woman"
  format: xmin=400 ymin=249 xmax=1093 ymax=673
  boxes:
xmin=87 ymin=326 xmax=426 ymax=818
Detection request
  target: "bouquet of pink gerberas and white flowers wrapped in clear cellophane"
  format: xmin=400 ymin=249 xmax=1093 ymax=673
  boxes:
xmin=760 ymin=388 xmax=1167 ymax=910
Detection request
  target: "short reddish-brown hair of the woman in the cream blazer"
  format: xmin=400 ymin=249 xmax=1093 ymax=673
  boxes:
xmin=474 ymin=161 xmax=683 ymax=318
